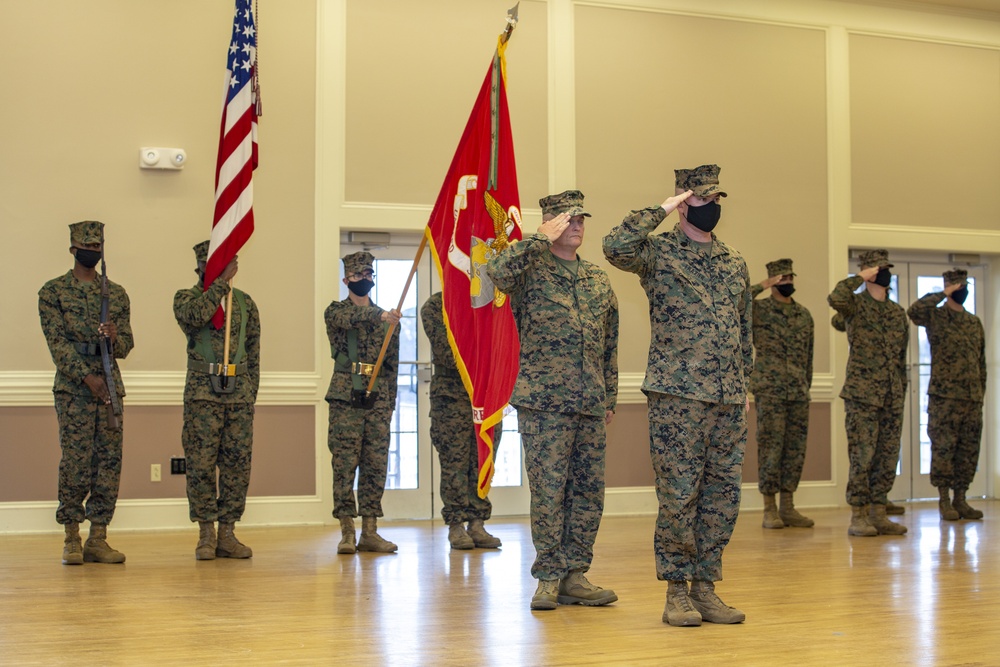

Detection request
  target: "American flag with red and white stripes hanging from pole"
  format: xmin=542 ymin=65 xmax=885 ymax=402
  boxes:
xmin=204 ymin=0 xmax=258 ymax=329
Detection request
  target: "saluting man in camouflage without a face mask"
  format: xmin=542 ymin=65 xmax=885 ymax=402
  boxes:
xmin=487 ymin=190 xmax=618 ymax=609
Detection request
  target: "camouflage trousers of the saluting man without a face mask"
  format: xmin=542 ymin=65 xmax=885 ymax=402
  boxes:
xmin=517 ymin=408 xmax=606 ymax=579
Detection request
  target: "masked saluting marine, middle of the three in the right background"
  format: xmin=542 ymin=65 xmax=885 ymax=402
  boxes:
xmin=827 ymin=250 xmax=909 ymax=537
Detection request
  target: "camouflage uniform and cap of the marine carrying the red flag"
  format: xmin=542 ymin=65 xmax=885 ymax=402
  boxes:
xmin=324 ymin=253 xmax=399 ymax=519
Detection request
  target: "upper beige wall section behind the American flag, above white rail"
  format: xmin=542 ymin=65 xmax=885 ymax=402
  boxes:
xmin=0 ymin=0 xmax=316 ymax=372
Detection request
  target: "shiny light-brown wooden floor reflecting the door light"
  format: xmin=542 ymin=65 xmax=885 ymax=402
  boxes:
xmin=0 ymin=501 xmax=1000 ymax=667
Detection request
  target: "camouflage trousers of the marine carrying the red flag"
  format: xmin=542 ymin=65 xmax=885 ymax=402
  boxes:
xmin=327 ymin=401 xmax=392 ymax=519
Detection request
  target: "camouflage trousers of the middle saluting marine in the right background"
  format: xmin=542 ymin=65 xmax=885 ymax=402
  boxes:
xmin=844 ymin=399 xmax=903 ymax=507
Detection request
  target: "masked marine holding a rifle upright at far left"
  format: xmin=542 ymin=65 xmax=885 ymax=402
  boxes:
xmin=38 ymin=220 xmax=133 ymax=565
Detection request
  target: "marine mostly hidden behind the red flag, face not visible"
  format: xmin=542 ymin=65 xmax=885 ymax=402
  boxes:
xmin=420 ymin=292 xmax=503 ymax=549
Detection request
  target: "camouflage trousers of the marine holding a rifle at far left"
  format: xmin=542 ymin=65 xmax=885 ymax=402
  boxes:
xmin=55 ymin=392 xmax=125 ymax=525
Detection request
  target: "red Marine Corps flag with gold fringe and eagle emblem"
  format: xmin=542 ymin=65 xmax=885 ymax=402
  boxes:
xmin=425 ymin=6 xmax=521 ymax=498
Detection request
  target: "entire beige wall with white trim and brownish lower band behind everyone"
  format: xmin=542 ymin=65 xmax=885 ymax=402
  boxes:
xmin=0 ymin=0 xmax=1000 ymax=532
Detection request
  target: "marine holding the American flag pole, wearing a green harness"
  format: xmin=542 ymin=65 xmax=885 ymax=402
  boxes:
xmin=174 ymin=241 xmax=260 ymax=560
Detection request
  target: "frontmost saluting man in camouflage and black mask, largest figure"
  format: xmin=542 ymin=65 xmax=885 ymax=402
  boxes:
xmin=604 ymin=165 xmax=753 ymax=625
